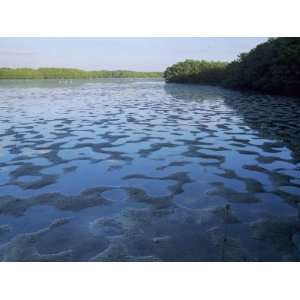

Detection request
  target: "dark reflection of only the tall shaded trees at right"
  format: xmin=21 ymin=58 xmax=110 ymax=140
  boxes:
xmin=224 ymin=93 xmax=300 ymax=162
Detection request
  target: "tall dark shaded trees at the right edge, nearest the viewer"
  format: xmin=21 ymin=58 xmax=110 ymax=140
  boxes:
xmin=223 ymin=38 xmax=300 ymax=96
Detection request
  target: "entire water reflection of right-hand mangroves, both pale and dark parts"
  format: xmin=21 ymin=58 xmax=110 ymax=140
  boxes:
xmin=165 ymin=84 xmax=300 ymax=162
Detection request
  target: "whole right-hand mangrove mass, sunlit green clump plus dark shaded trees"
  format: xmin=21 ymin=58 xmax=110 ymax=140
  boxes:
xmin=164 ymin=38 xmax=300 ymax=96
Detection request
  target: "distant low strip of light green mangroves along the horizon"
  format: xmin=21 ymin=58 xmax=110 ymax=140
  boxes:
xmin=0 ymin=68 xmax=161 ymax=79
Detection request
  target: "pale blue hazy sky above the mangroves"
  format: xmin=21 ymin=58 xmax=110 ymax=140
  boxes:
xmin=0 ymin=37 xmax=267 ymax=71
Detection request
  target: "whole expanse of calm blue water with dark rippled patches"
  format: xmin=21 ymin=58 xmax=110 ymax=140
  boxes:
xmin=0 ymin=79 xmax=300 ymax=261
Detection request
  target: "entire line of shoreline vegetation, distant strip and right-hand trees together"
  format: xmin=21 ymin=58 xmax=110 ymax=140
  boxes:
xmin=0 ymin=37 xmax=300 ymax=97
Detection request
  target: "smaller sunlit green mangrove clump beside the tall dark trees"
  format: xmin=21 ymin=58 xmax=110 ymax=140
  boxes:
xmin=164 ymin=59 xmax=226 ymax=85
